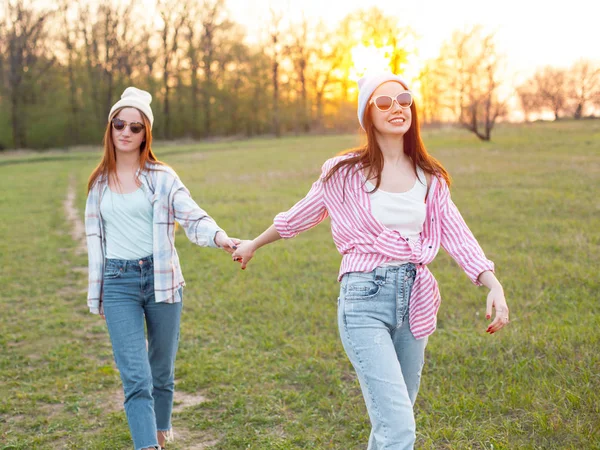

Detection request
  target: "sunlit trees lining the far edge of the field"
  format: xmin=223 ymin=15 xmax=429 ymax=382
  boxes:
xmin=0 ymin=0 xmax=599 ymax=149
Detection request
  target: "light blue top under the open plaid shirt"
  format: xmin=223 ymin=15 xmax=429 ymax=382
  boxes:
xmin=100 ymin=187 xmax=154 ymax=259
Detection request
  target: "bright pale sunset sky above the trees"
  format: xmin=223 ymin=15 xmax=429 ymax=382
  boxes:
xmin=227 ymin=0 xmax=600 ymax=82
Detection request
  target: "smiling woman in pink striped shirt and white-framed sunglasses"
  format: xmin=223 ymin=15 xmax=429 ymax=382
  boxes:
xmin=232 ymin=73 xmax=508 ymax=450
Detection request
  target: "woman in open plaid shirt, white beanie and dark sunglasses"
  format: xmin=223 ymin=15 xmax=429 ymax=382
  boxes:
xmin=85 ymin=87 xmax=239 ymax=450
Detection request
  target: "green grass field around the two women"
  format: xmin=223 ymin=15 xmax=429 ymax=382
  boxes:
xmin=0 ymin=121 xmax=600 ymax=450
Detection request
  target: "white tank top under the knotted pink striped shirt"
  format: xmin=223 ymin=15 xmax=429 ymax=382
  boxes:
xmin=366 ymin=167 xmax=427 ymax=266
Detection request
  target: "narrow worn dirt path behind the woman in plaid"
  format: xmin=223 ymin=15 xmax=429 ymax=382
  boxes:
xmin=63 ymin=176 xmax=218 ymax=450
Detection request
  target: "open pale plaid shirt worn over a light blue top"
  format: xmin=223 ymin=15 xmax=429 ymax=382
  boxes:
xmin=85 ymin=164 xmax=223 ymax=314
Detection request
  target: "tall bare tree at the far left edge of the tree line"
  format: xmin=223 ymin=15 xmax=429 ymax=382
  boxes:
xmin=0 ymin=0 xmax=55 ymax=148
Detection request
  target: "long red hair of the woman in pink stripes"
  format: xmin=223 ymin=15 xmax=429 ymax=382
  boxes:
xmin=324 ymin=86 xmax=451 ymax=191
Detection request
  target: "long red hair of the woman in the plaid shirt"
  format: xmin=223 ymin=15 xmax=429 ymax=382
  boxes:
xmin=88 ymin=106 xmax=164 ymax=193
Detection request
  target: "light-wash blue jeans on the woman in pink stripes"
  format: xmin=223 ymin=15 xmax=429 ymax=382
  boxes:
xmin=338 ymin=264 xmax=427 ymax=450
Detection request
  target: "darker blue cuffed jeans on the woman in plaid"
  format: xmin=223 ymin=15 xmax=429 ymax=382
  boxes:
xmin=103 ymin=256 xmax=182 ymax=449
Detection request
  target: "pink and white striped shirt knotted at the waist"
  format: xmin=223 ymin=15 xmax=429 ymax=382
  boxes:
xmin=274 ymin=156 xmax=494 ymax=339
